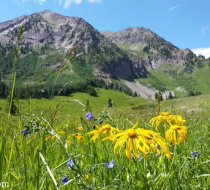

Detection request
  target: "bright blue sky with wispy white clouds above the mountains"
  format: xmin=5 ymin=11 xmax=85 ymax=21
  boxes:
xmin=0 ymin=0 xmax=210 ymax=57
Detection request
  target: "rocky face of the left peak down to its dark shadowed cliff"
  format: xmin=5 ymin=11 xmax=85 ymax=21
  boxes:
xmin=0 ymin=11 xmax=148 ymax=79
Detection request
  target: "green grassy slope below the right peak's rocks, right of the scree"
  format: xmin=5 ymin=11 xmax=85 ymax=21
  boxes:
xmin=135 ymin=60 xmax=210 ymax=96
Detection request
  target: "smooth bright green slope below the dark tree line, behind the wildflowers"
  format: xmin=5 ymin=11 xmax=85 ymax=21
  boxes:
xmin=0 ymin=88 xmax=149 ymax=120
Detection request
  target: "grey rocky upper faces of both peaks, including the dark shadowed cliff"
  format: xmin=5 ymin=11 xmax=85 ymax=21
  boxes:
xmin=0 ymin=11 xmax=195 ymax=80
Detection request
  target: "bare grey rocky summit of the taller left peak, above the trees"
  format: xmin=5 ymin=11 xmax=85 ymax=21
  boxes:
xmin=0 ymin=11 xmax=101 ymax=50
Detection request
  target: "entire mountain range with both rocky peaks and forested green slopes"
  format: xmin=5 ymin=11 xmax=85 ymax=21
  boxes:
xmin=0 ymin=10 xmax=208 ymax=98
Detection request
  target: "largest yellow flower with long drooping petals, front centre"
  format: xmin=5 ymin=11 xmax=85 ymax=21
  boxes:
xmin=103 ymin=122 xmax=171 ymax=161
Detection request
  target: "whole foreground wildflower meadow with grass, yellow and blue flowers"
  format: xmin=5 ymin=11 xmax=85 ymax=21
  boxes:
xmin=0 ymin=25 xmax=210 ymax=190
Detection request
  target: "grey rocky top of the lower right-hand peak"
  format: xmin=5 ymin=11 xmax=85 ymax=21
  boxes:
xmin=101 ymin=27 xmax=196 ymax=69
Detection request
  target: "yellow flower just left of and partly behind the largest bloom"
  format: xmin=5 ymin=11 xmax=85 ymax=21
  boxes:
xmin=87 ymin=124 xmax=122 ymax=143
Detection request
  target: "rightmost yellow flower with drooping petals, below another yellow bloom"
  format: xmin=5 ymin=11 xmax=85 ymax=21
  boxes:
xmin=165 ymin=125 xmax=187 ymax=144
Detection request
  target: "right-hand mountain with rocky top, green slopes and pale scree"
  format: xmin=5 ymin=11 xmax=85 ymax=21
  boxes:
xmin=101 ymin=27 xmax=210 ymax=98
